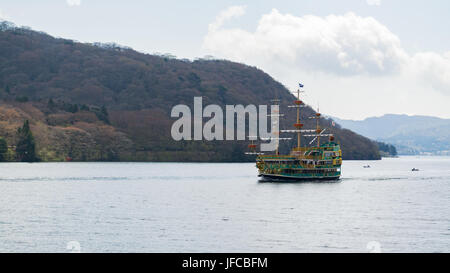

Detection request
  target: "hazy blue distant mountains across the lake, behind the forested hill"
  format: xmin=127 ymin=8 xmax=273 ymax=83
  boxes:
xmin=333 ymin=114 xmax=450 ymax=154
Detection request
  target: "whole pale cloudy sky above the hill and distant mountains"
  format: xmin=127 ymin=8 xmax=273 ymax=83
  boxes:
xmin=0 ymin=0 xmax=450 ymax=120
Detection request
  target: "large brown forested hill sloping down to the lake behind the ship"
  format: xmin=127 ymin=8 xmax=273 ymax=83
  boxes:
xmin=0 ymin=22 xmax=379 ymax=161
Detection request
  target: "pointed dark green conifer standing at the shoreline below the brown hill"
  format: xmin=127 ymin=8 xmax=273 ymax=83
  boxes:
xmin=16 ymin=120 xmax=38 ymax=162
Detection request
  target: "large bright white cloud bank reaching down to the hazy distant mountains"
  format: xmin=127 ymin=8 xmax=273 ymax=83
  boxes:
xmin=203 ymin=9 xmax=450 ymax=118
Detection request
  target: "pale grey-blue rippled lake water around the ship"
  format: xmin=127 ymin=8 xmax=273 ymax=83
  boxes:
xmin=0 ymin=157 xmax=450 ymax=252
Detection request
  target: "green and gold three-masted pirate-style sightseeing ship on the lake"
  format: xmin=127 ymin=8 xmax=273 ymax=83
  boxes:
xmin=249 ymin=84 xmax=342 ymax=181
